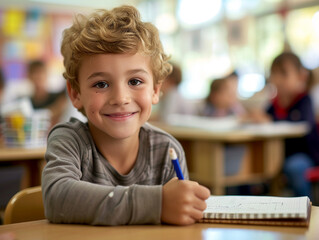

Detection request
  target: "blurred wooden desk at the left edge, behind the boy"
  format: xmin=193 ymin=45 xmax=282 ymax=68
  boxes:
xmin=0 ymin=146 xmax=45 ymax=188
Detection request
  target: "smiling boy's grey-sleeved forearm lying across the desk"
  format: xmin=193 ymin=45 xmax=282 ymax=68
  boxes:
xmin=42 ymin=167 xmax=162 ymax=225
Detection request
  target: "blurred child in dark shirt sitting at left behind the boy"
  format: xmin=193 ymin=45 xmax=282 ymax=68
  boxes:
xmin=28 ymin=60 xmax=67 ymax=125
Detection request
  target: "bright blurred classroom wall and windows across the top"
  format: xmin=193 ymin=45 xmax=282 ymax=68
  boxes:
xmin=0 ymin=0 xmax=319 ymax=102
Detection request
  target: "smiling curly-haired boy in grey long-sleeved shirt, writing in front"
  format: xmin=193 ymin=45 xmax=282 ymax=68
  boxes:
xmin=42 ymin=6 xmax=210 ymax=225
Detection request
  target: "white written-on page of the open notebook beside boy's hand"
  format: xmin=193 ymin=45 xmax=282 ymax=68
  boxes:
xmin=204 ymin=196 xmax=309 ymax=219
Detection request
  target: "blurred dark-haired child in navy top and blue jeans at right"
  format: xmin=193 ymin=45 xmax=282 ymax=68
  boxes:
xmin=267 ymin=53 xmax=319 ymax=196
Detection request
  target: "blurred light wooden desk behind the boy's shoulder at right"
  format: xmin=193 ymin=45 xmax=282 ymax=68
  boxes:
xmin=152 ymin=122 xmax=307 ymax=195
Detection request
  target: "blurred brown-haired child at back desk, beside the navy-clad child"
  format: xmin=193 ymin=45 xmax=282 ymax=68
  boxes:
xmin=201 ymin=72 xmax=244 ymax=117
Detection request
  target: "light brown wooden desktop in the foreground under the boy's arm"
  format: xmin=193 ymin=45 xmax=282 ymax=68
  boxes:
xmin=0 ymin=207 xmax=319 ymax=240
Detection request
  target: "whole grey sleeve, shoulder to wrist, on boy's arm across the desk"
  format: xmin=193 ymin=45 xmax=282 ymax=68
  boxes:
xmin=42 ymin=129 xmax=162 ymax=225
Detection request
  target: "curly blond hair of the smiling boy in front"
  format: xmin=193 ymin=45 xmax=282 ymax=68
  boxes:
xmin=61 ymin=6 xmax=172 ymax=91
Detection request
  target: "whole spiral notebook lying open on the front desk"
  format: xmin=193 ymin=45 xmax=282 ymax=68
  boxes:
xmin=200 ymin=196 xmax=311 ymax=226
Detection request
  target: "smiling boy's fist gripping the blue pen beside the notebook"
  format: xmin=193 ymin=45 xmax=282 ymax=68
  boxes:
xmin=161 ymin=178 xmax=210 ymax=225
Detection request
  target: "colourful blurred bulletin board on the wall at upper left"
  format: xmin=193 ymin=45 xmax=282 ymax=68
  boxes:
xmin=0 ymin=8 xmax=72 ymax=82
